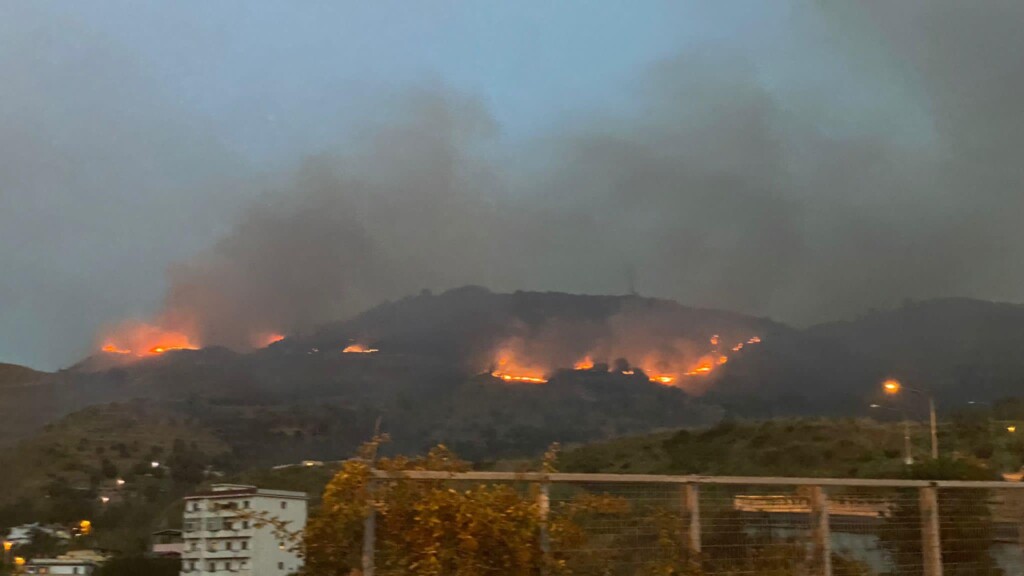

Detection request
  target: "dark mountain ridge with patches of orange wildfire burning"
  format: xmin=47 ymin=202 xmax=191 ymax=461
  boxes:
xmin=9 ymin=287 xmax=1024 ymax=464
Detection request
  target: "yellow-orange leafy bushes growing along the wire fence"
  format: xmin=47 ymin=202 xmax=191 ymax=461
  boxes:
xmin=304 ymin=438 xmax=867 ymax=576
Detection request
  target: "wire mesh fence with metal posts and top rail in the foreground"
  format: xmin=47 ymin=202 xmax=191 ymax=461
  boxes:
xmin=362 ymin=471 xmax=1024 ymax=576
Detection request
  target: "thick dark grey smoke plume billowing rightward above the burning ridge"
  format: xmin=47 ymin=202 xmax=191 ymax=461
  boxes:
xmin=132 ymin=0 xmax=1024 ymax=346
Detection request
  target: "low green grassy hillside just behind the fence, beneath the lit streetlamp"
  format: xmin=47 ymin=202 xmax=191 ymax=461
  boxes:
xmin=559 ymin=412 xmax=1024 ymax=478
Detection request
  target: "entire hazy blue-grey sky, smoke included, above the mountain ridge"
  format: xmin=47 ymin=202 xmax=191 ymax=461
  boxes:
xmin=0 ymin=0 xmax=1024 ymax=369
